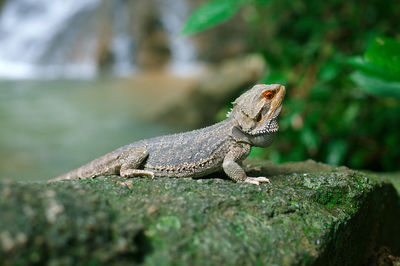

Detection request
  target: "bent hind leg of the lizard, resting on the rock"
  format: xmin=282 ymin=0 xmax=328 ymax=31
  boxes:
xmin=119 ymin=147 xmax=154 ymax=178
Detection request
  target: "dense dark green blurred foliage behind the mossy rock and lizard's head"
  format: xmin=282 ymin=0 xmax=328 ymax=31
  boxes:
xmin=186 ymin=0 xmax=400 ymax=171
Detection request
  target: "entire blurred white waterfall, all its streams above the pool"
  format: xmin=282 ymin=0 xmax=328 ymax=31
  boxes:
xmin=0 ymin=0 xmax=196 ymax=79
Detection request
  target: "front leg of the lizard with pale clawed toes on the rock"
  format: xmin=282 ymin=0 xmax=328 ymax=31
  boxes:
xmin=222 ymin=147 xmax=270 ymax=185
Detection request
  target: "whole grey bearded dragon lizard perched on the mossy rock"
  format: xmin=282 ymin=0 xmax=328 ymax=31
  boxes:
xmin=49 ymin=84 xmax=286 ymax=185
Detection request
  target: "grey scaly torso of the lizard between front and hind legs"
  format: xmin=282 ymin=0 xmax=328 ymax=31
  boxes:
xmin=128 ymin=119 xmax=233 ymax=177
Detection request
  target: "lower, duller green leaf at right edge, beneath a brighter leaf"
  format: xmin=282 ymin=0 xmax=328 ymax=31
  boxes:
xmin=350 ymin=71 xmax=400 ymax=98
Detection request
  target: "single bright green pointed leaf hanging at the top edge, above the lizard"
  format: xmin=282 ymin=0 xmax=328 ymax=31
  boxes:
xmin=182 ymin=0 xmax=244 ymax=34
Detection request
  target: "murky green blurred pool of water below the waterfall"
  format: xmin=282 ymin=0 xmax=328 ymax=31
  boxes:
xmin=0 ymin=79 xmax=173 ymax=180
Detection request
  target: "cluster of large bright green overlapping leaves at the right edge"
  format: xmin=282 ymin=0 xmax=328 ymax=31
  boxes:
xmin=348 ymin=37 xmax=400 ymax=97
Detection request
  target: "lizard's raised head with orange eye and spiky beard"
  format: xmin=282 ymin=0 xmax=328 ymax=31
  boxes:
xmin=232 ymin=84 xmax=286 ymax=147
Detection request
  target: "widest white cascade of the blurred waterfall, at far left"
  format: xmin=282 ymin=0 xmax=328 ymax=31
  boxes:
xmin=0 ymin=0 xmax=100 ymax=79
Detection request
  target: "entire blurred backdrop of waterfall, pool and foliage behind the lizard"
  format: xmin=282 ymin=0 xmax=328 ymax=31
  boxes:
xmin=0 ymin=0 xmax=400 ymax=180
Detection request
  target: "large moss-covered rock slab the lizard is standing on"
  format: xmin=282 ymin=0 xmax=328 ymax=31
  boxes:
xmin=0 ymin=161 xmax=400 ymax=265
